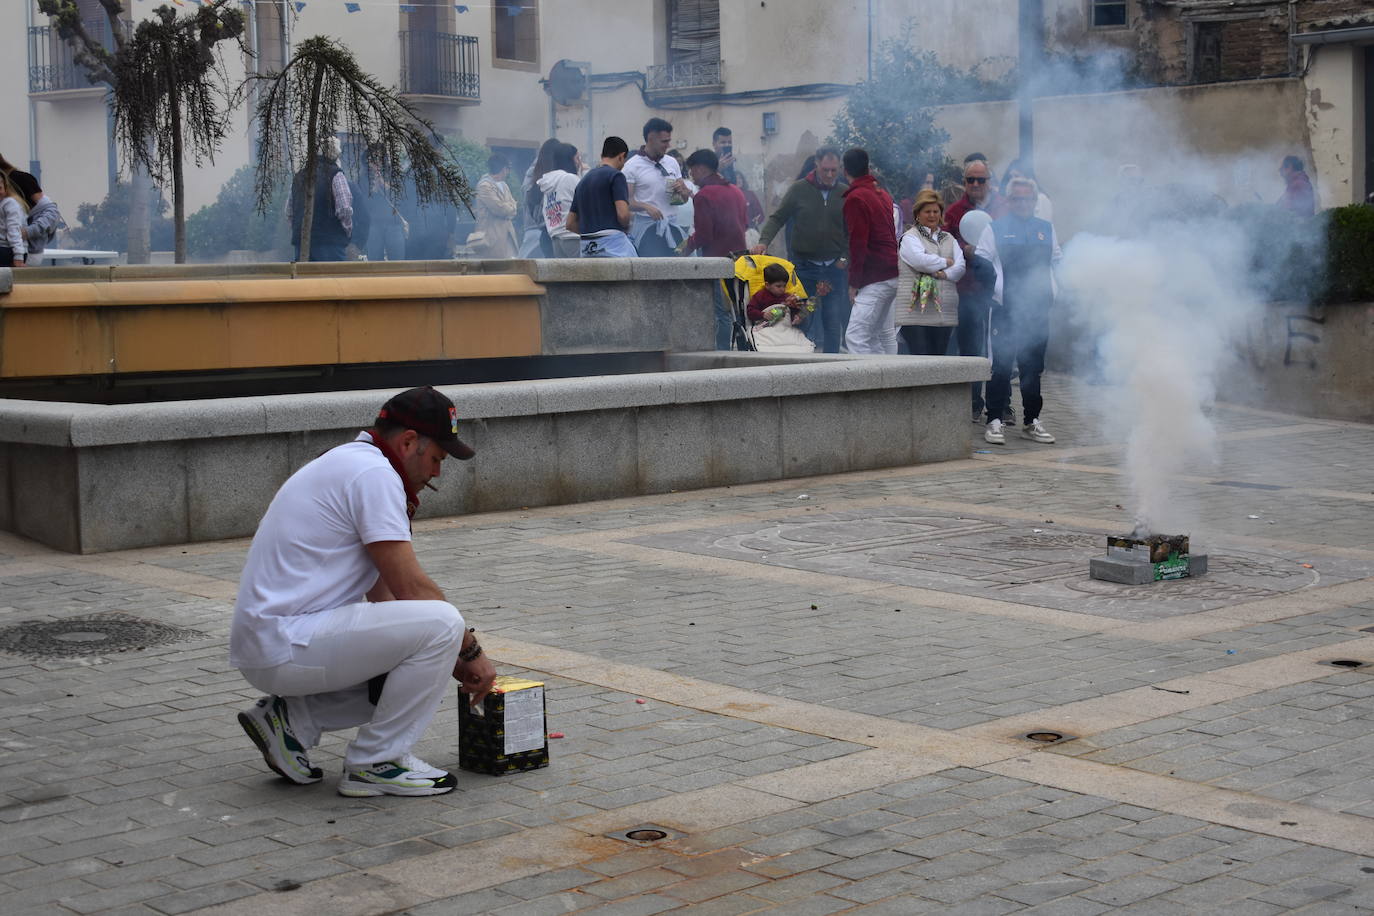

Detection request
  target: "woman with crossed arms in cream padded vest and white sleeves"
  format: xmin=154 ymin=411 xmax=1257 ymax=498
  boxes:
xmin=894 ymin=190 xmax=965 ymax=356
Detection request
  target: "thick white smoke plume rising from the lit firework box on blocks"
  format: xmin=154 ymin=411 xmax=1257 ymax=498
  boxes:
xmin=1041 ymin=93 xmax=1319 ymax=534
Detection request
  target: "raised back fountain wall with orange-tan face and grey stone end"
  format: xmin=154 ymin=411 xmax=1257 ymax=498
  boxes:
xmin=0 ymin=258 xmax=734 ymax=378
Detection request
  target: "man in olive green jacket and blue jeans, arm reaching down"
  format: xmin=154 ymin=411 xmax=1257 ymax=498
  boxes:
xmin=753 ymin=147 xmax=851 ymax=353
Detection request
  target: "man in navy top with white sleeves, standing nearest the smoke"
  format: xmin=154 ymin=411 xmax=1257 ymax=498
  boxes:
xmin=977 ymin=179 xmax=1062 ymax=445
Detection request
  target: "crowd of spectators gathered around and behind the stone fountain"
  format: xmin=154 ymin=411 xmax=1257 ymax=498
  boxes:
xmin=0 ymin=137 xmax=1316 ymax=445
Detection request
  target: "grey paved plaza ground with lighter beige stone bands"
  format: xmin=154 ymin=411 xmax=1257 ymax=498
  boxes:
xmin=0 ymin=378 xmax=1374 ymax=916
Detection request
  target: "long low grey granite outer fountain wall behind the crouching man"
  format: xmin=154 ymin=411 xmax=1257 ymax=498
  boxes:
xmin=0 ymin=352 xmax=988 ymax=553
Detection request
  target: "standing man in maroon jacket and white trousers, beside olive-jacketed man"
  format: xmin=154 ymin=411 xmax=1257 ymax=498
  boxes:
xmin=842 ymin=148 xmax=897 ymax=354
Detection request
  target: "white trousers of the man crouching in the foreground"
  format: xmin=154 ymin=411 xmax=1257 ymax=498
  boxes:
xmin=242 ymin=602 xmax=464 ymax=769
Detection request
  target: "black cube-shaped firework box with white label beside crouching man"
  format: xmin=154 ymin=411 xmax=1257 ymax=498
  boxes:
xmin=458 ymin=674 xmax=548 ymax=776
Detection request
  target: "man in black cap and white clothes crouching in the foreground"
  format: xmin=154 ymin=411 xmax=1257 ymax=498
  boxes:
xmin=229 ymin=387 xmax=496 ymax=797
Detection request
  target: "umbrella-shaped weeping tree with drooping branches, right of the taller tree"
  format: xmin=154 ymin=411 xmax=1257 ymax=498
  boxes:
xmin=245 ymin=36 xmax=473 ymax=261
